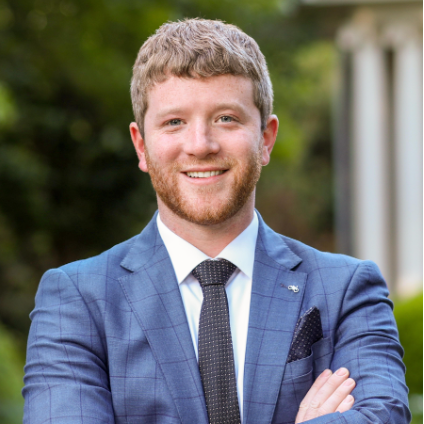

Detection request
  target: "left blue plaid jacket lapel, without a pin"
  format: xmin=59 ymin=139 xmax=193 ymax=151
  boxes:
xmin=120 ymin=216 xmax=208 ymax=423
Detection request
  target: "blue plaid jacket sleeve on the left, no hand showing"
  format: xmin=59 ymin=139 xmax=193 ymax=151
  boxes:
xmin=22 ymin=269 xmax=115 ymax=424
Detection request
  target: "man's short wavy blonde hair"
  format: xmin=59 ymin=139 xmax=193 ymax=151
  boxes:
xmin=131 ymin=18 xmax=273 ymax=134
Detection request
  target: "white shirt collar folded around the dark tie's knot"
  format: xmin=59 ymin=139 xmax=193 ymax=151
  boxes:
xmin=156 ymin=212 xmax=259 ymax=284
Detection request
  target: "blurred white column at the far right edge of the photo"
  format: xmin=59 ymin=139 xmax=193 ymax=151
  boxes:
xmin=394 ymin=28 xmax=423 ymax=295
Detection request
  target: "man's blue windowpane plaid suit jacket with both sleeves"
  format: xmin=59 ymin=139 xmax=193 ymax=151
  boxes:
xmin=23 ymin=214 xmax=410 ymax=424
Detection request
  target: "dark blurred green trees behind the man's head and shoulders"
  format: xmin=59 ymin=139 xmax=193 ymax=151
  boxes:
xmin=0 ymin=0 xmax=334 ymax=338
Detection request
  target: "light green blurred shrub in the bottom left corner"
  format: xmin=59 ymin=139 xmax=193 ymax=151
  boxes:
xmin=0 ymin=325 xmax=24 ymax=424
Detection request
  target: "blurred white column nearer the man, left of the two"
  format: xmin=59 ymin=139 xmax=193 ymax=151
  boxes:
xmin=352 ymin=37 xmax=391 ymax=280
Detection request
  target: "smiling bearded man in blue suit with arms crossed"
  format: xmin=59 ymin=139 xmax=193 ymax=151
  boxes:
xmin=23 ymin=19 xmax=410 ymax=424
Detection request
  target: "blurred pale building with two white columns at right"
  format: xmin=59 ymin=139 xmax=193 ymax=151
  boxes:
xmin=304 ymin=0 xmax=423 ymax=296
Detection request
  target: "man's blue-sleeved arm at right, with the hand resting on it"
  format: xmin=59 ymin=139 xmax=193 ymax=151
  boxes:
xmin=295 ymin=262 xmax=411 ymax=424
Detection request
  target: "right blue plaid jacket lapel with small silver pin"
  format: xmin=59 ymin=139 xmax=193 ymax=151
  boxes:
xmin=243 ymin=218 xmax=307 ymax=424
